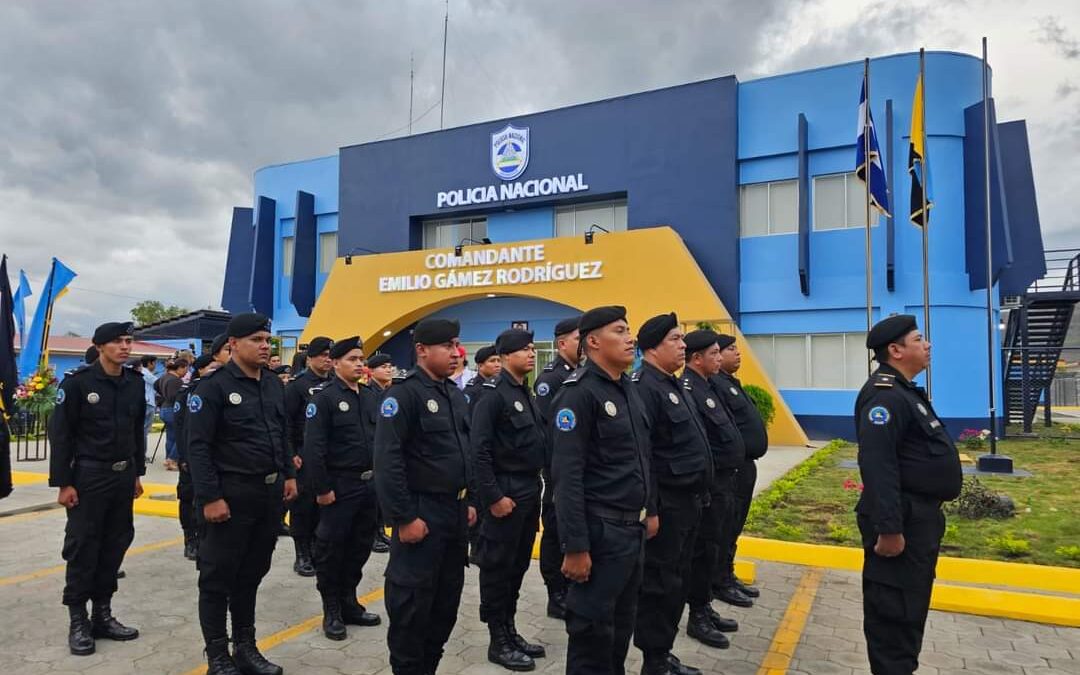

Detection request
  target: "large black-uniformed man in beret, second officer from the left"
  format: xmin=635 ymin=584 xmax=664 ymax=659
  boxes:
xmin=185 ymin=313 xmax=296 ymax=675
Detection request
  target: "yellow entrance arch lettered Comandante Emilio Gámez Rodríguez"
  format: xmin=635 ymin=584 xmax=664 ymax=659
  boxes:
xmin=301 ymin=227 xmax=807 ymax=445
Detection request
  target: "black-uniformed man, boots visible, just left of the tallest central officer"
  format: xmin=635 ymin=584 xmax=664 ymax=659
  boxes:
xmin=470 ymin=328 xmax=548 ymax=671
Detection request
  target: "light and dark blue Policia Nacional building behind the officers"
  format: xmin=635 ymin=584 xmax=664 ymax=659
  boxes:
xmin=221 ymin=52 xmax=1045 ymax=437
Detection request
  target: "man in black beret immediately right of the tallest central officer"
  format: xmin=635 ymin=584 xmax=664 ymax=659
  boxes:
xmin=631 ymin=313 xmax=713 ymax=675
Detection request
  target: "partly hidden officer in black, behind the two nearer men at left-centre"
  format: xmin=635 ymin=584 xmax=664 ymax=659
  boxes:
xmin=285 ymin=336 xmax=334 ymax=577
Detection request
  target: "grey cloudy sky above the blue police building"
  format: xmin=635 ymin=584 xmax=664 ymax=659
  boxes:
xmin=0 ymin=0 xmax=1080 ymax=335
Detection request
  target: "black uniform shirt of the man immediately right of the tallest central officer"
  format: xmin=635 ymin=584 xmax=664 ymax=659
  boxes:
xmin=631 ymin=361 xmax=713 ymax=498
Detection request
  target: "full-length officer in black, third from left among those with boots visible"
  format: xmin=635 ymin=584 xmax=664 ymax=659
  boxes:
xmin=301 ymin=336 xmax=381 ymax=640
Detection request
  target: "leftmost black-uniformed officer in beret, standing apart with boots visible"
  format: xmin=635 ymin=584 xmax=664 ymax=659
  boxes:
xmin=49 ymin=323 xmax=146 ymax=656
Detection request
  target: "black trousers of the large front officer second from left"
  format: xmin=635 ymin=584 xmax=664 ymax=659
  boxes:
xmin=199 ymin=473 xmax=284 ymax=644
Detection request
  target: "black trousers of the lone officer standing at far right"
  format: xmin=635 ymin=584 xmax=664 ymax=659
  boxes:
xmin=858 ymin=494 xmax=945 ymax=675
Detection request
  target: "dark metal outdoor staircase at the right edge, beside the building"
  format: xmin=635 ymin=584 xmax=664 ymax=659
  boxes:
xmin=1002 ymin=249 xmax=1080 ymax=432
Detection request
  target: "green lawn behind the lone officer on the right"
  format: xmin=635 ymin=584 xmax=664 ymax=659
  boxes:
xmin=746 ymin=440 xmax=1080 ymax=568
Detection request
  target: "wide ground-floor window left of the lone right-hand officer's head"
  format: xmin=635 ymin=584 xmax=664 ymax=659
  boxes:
xmin=746 ymin=333 xmax=867 ymax=389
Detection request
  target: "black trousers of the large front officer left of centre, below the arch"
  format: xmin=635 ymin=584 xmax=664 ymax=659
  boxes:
xmin=386 ymin=492 xmax=469 ymax=675
